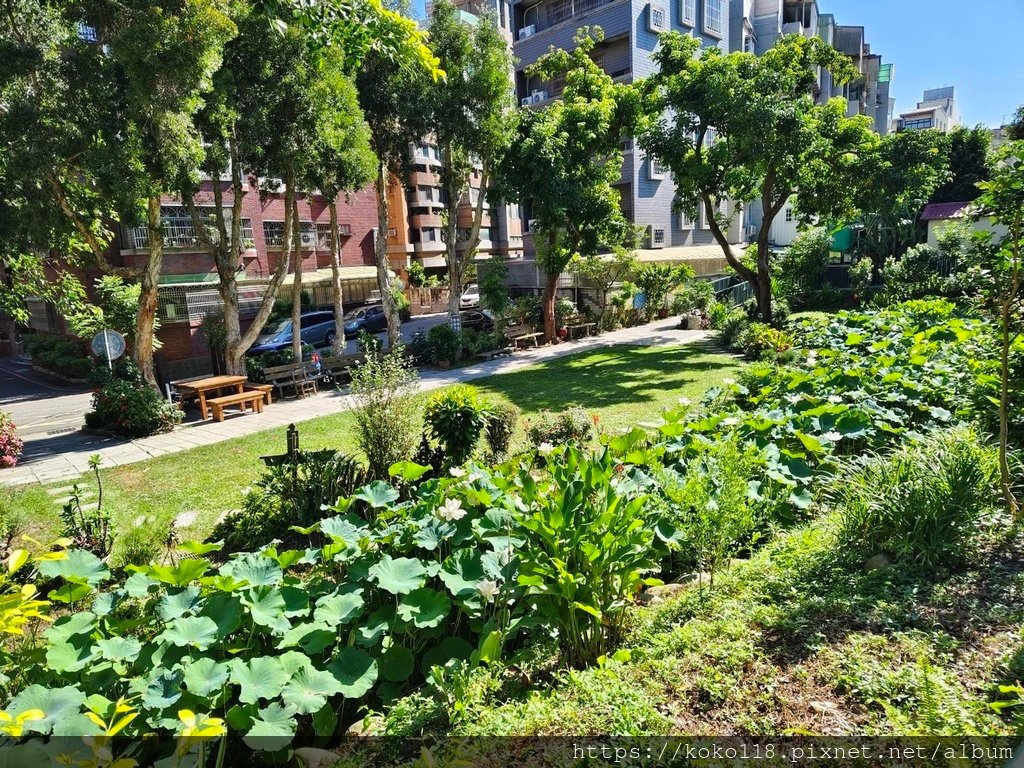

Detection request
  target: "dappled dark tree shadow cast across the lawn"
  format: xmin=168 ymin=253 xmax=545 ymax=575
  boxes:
xmin=474 ymin=343 xmax=738 ymax=416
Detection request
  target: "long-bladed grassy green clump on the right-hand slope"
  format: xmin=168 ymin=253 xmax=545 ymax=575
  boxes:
xmin=827 ymin=427 xmax=998 ymax=567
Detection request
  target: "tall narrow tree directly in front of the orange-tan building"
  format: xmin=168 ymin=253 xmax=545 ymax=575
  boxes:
xmin=423 ymin=0 xmax=515 ymax=318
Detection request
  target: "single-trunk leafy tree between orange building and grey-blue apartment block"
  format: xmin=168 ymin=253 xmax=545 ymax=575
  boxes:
xmin=501 ymin=28 xmax=635 ymax=341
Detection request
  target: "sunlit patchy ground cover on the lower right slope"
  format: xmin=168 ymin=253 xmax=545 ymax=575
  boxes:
xmin=372 ymin=515 xmax=1024 ymax=745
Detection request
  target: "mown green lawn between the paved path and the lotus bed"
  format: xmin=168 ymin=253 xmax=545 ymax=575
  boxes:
xmin=0 ymin=345 xmax=741 ymax=552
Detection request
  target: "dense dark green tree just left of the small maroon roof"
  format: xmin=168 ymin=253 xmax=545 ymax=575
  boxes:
xmin=855 ymin=131 xmax=951 ymax=270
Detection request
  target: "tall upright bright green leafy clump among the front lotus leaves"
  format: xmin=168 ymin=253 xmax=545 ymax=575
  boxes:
xmin=515 ymin=446 xmax=658 ymax=667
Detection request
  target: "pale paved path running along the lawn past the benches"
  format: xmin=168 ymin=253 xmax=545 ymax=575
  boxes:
xmin=0 ymin=319 xmax=709 ymax=485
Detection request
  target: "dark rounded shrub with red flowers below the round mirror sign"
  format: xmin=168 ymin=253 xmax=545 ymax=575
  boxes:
xmin=85 ymin=379 xmax=184 ymax=437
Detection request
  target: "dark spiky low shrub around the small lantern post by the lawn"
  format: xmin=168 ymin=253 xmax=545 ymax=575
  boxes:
xmin=211 ymin=450 xmax=368 ymax=552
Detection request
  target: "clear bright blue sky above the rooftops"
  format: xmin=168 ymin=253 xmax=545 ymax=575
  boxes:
xmin=414 ymin=0 xmax=1024 ymax=126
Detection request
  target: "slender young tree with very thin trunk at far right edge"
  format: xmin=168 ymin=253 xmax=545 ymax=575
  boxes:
xmin=974 ymin=141 xmax=1024 ymax=516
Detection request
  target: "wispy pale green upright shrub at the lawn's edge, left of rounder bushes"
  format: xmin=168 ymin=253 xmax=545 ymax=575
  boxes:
xmin=351 ymin=348 xmax=420 ymax=479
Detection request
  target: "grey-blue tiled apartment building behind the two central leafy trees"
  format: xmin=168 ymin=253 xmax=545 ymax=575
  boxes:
xmin=513 ymin=0 xmax=742 ymax=268
